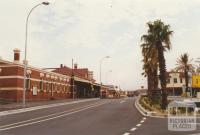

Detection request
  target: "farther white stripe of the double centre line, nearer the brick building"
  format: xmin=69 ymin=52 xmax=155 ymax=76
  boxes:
xmin=0 ymin=101 xmax=104 ymax=128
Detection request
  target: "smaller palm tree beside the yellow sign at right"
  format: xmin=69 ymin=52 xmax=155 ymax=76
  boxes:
xmin=176 ymin=53 xmax=195 ymax=92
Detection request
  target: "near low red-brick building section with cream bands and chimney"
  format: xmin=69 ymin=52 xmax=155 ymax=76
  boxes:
xmin=0 ymin=49 xmax=72 ymax=102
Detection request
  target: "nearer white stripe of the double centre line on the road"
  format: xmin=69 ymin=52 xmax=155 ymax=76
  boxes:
xmin=0 ymin=102 xmax=108 ymax=131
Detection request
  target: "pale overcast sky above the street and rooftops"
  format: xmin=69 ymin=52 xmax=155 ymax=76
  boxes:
xmin=0 ymin=0 xmax=200 ymax=90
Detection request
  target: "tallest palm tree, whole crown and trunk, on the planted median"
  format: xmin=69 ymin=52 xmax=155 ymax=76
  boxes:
xmin=142 ymin=20 xmax=173 ymax=109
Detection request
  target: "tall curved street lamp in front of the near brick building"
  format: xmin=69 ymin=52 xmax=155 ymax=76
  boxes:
xmin=23 ymin=2 xmax=49 ymax=107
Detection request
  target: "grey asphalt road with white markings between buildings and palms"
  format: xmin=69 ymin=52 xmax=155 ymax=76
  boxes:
xmin=0 ymin=98 xmax=200 ymax=135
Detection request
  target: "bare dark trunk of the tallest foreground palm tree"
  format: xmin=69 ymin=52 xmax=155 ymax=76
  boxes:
xmin=157 ymin=41 xmax=167 ymax=109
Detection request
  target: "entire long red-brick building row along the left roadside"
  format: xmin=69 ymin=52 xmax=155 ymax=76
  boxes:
xmin=0 ymin=49 xmax=119 ymax=102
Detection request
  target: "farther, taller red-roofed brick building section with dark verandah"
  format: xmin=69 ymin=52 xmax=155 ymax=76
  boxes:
xmin=53 ymin=64 xmax=100 ymax=98
